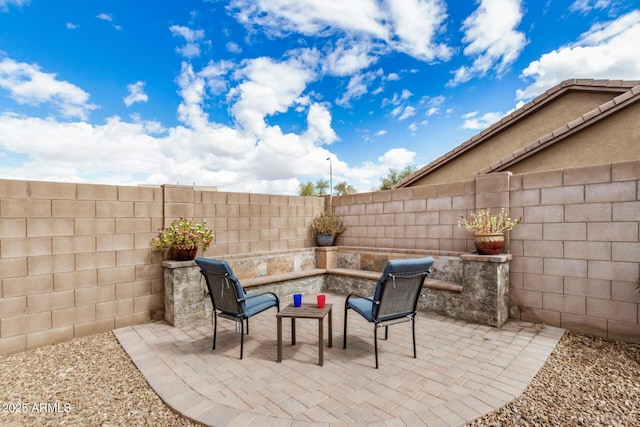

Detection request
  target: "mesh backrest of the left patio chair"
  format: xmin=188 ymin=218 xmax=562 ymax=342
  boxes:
xmin=195 ymin=258 xmax=245 ymax=316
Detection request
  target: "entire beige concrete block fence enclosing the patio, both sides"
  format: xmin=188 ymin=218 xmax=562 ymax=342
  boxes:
xmin=0 ymin=161 xmax=640 ymax=353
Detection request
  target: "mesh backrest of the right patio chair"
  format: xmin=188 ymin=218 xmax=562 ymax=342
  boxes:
xmin=373 ymin=257 xmax=435 ymax=322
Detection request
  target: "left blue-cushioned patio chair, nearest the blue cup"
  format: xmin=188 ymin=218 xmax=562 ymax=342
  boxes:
xmin=195 ymin=258 xmax=280 ymax=359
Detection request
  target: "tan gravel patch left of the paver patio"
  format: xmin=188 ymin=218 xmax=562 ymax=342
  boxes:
xmin=0 ymin=332 xmax=195 ymax=427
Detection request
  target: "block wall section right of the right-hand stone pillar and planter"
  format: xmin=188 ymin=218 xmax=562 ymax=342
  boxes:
xmin=510 ymin=161 xmax=640 ymax=342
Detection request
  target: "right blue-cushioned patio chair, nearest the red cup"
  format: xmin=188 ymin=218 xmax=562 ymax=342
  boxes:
xmin=342 ymin=257 xmax=435 ymax=369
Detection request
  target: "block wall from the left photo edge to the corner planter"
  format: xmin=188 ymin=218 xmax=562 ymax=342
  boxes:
xmin=0 ymin=180 xmax=325 ymax=353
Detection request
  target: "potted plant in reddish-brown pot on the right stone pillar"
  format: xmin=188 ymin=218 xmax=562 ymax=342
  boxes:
xmin=458 ymin=208 xmax=522 ymax=255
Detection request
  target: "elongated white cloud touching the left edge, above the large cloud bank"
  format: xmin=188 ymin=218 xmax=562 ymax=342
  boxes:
xmin=0 ymin=58 xmax=97 ymax=119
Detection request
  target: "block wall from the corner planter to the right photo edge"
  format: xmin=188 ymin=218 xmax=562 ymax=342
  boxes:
xmin=333 ymin=161 xmax=640 ymax=342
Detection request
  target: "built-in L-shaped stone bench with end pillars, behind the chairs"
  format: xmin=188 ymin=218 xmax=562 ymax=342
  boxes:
xmin=162 ymin=246 xmax=511 ymax=327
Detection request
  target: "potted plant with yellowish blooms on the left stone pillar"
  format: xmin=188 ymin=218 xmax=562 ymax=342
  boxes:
xmin=151 ymin=218 xmax=214 ymax=261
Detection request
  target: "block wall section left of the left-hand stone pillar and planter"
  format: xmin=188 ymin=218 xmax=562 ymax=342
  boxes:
xmin=0 ymin=180 xmax=163 ymax=353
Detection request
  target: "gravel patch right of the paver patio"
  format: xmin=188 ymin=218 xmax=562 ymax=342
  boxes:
xmin=469 ymin=332 xmax=640 ymax=427
